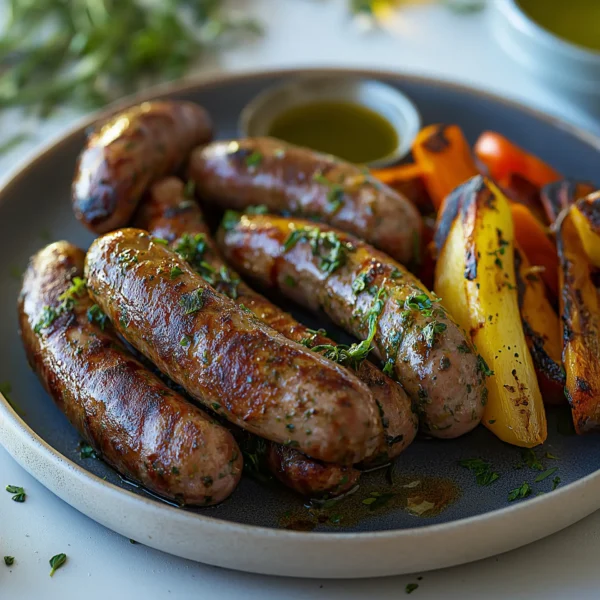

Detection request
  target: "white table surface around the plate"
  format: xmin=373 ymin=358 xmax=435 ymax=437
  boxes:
xmin=0 ymin=0 xmax=600 ymax=600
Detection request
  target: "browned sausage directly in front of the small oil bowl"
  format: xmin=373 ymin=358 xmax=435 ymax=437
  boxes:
xmin=188 ymin=138 xmax=422 ymax=264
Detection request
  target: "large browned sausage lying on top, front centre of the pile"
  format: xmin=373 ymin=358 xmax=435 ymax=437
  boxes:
xmin=85 ymin=229 xmax=381 ymax=464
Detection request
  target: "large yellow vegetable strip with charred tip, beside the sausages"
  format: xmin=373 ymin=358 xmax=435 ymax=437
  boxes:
xmin=435 ymin=176 xmax=546 ymax=447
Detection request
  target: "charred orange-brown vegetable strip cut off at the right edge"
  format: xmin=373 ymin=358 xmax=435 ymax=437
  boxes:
xmin=556 ymin=209 xmax=600 ymax=434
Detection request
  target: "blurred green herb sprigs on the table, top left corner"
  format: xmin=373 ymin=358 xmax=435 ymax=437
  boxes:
xmin=0 ymin=0 xmax=260 ymax=115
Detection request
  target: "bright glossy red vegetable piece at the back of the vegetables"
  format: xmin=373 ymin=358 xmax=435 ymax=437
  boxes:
xmin=475 ymin=131 xmax=561 ymax=188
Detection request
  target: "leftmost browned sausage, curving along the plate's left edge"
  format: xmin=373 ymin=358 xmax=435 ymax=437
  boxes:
xmin=19 ymin=242 xmax=242 ymax=505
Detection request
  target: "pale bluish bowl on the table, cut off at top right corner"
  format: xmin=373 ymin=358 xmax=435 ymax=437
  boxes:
xmin=489 ymin=0 xmax=600 ymax=115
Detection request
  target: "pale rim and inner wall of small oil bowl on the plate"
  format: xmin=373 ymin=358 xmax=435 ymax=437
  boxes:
xmin=239 ymin=75 xmax=421 ymax=167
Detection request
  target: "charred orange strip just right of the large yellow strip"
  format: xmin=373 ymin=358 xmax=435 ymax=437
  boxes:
xmin=515 ymin=247 xmax=565 ymax=404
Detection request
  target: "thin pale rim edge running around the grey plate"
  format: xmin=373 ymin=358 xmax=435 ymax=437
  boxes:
xmin=0 ymin=67 xmax=600 ymax=545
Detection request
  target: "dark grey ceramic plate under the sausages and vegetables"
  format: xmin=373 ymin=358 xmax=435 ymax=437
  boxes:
xmin=0 ymin=72 xmax=600 ymax=577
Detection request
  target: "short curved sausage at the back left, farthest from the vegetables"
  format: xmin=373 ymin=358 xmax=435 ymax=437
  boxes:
xmin=72 ymin=101 xmax=212 ymax=233
